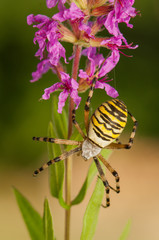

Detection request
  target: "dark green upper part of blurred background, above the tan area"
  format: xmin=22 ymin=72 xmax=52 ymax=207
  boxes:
xmin=0 ymin=0 xmax=159 ymax=166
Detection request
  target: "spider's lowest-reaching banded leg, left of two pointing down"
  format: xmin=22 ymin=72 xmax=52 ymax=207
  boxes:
xmin=93 ymin=157 xmax=110 ymax=208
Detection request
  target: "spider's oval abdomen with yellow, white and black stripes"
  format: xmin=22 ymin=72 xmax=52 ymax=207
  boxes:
xmin=88 ymin=99 xmax=128 ymax=148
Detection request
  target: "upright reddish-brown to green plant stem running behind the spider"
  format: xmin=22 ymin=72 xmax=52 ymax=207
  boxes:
xmin=65 ymin=46 xmax=82 ymax=240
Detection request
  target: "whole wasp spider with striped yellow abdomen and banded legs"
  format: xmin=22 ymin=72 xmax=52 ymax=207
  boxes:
xmin=33 ymin=79 xmax=137 ymax=207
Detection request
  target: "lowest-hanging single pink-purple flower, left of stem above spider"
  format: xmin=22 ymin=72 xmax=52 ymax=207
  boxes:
xmin=42 ymin=72 xmax=81 ymax=113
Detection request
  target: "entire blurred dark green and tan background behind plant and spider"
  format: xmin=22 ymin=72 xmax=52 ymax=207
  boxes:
xmin=0 ymin=0 xmax=159 ymax=240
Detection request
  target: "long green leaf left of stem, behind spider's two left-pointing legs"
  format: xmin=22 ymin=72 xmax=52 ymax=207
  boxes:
xmin=48 ymin=96 xmax=70 ymax=209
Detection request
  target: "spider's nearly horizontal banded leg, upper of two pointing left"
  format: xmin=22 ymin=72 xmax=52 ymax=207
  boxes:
xmin=33 ymin=137 xmax=81 ymax=145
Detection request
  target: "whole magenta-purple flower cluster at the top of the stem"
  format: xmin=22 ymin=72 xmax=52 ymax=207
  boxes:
xmin=27 ymin=0 xmax=137 ymax=113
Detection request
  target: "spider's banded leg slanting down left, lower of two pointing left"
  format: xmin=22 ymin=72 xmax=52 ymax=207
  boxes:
xmin=33 ymin=147 xmax=81 ymax=177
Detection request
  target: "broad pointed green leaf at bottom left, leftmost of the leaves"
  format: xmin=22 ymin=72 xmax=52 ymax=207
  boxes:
xmin=13 ymin=188 xmax=44 ymax=240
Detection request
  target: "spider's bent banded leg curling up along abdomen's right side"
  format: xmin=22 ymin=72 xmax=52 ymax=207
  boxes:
xmin=105 ymin=112 xmax=138 ymax=149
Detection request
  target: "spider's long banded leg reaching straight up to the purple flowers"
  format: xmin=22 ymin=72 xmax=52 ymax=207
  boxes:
xmin=84 ymin=78 xmax=96 ymax=133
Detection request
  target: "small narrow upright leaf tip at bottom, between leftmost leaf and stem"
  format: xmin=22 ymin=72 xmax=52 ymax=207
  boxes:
xmin=43 ymin=199 xmax=54 ymax=240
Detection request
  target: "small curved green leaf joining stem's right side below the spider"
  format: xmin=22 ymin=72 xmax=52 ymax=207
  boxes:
xmin=71 ymin=161 xmax=97 ymax=205
